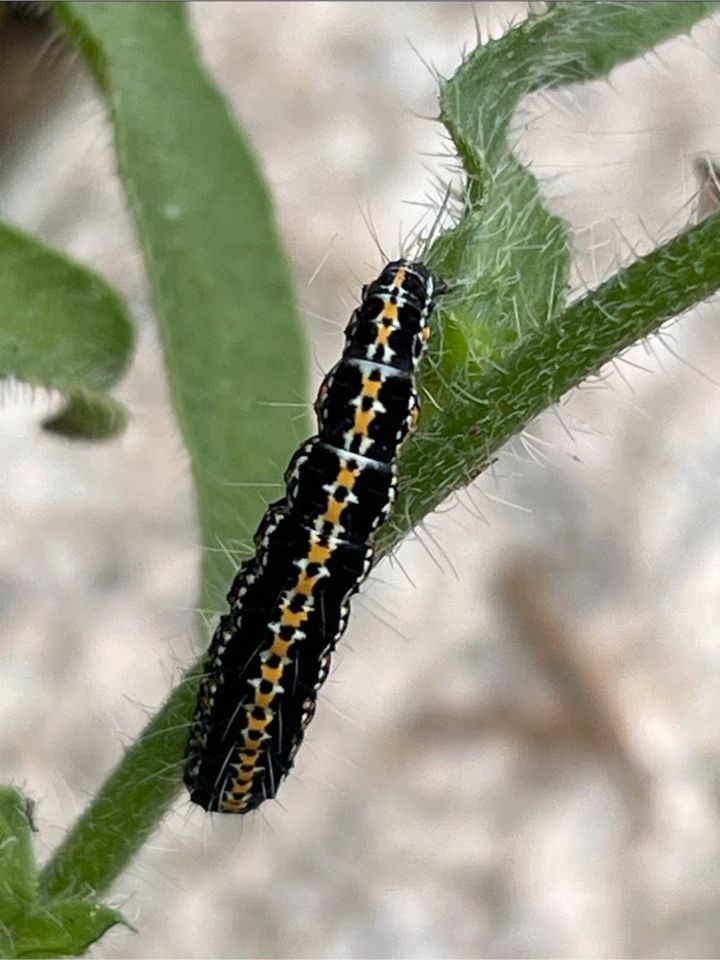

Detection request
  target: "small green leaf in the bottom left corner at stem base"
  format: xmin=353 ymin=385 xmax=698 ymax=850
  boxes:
xmin=0 ymin=787 xmax=132 ymax=958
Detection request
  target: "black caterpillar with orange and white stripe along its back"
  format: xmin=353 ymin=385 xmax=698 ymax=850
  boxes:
xmin=184 ymin=259 xmax=447 ymax=813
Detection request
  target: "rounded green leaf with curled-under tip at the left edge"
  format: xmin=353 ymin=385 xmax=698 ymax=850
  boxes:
xmin=0 ymin=223 xmax=133 ymax=439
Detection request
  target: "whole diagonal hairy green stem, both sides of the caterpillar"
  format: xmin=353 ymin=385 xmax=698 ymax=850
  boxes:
xmin=40 ymin=213 xmax=720 ymax=896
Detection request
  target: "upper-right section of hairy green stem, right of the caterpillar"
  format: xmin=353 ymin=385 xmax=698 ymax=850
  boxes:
xmin=386 ymin=213 xmax=720 ymax=554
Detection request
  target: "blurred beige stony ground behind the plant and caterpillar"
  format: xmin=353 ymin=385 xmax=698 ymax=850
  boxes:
xmin=0 ymin=3 xmax=720 ymax=958
